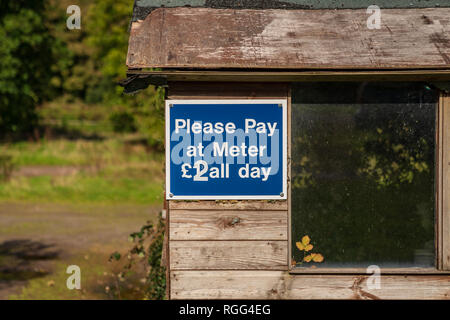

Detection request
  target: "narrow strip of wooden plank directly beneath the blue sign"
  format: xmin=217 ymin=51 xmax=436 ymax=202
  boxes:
xmin=169 ymin=200 xmax=288 ymax=211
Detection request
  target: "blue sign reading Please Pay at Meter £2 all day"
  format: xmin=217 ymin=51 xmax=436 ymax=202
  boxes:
xmin=166 ymin=100 xmax=287 ymax=199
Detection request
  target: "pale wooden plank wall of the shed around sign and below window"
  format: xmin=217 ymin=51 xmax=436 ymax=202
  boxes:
xmin=168 ymin=82 xmax=450 ymax=299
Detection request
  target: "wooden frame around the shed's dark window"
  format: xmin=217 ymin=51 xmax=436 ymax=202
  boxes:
xmin=287 ymin=83 xmax=450 ymax=275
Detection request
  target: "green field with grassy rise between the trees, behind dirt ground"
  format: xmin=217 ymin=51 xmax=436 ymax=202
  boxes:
xmin=0 ymin=103 xmax=164 ymax=204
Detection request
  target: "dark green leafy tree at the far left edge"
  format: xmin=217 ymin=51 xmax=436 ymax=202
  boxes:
xmin=0 ymin=0 xmax=55 ymax=137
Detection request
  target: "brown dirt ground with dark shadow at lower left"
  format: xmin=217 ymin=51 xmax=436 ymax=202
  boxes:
xmin=0 ymin=203 xmax=160 ymax=299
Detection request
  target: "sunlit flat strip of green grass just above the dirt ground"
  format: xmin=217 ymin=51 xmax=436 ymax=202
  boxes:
xmin=0 ymin=139 xmax=164 ymax=204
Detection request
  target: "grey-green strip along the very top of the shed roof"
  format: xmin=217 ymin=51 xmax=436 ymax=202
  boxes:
xmin=132 ymin=0 xmax=450 ymax=22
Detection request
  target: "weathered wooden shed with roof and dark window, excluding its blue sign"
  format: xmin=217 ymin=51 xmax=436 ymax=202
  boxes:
xmin=124 ymin=0 xmax=450 ymax=299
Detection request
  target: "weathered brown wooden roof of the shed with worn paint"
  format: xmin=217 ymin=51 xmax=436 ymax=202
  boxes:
xmin=122 ymin=0 xmax=450 ymax=93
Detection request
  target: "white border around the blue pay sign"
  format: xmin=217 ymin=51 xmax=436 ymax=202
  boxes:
xmin=166 ymin=99 xmax=288 ymax=200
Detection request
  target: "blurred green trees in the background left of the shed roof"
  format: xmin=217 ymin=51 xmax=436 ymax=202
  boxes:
xmin=0 ymin=0 xmax=163 ymax=150
